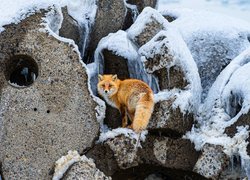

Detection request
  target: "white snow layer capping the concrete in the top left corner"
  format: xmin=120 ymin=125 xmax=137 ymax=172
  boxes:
xmin=0 ymin=0 xmax=97 ymax=32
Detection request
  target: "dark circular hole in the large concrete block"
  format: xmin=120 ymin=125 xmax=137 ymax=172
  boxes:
xmin=5 ymin=55 xmax=38 ymax=88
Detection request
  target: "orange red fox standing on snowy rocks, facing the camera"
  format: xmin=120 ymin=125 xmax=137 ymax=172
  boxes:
xmin=97 ymin=75 xmax=154 ymax=133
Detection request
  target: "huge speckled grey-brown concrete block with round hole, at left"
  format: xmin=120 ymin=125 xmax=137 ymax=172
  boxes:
xmin=0 ymin=11 xmax=99 ymax=179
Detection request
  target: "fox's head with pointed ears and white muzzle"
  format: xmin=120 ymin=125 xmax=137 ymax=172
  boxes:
xmin=97 ymin=74 xmax=119 ymax=96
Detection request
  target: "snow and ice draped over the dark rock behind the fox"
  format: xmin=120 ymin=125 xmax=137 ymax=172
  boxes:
xmin=94 ymin=30 xmax=158 ymax=92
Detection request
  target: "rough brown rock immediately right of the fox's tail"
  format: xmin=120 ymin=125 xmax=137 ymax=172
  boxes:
xmin=148 ymin=99 xmax=194 ymax=137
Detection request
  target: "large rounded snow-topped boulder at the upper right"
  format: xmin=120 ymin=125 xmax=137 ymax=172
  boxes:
xmin=162 ymin=9 xmax=250 ymax=100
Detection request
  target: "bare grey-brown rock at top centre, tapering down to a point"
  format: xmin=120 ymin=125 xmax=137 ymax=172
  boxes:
xmin=87 ymin=0 xmax=126 ymax=59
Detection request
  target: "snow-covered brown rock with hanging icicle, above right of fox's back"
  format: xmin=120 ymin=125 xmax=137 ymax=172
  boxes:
xmin=139 ymin=29 xmax=199 ymax=90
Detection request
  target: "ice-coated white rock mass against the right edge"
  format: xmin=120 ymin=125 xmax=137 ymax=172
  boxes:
xmin=186 ymin=47 xmax=250 ymax=174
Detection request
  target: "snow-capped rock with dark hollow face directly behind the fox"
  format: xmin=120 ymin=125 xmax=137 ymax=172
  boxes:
xmin=92 ymin=30 xmax=158 ymax=92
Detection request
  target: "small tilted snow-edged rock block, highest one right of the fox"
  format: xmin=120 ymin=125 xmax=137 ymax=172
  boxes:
xmin=128 ymin=7 xmax=168 ymax=47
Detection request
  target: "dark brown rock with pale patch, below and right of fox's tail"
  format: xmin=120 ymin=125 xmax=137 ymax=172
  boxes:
xmin=137 ymin=136 xmax=199 ymax=171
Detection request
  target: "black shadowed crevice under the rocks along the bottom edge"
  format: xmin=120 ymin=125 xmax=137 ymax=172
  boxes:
xmin=112 ymin=164 xmax=207 ymax=180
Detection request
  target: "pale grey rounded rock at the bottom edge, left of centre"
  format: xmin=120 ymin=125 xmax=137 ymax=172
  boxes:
xmin=62 ymin=158 xmax=111 ymax=180
